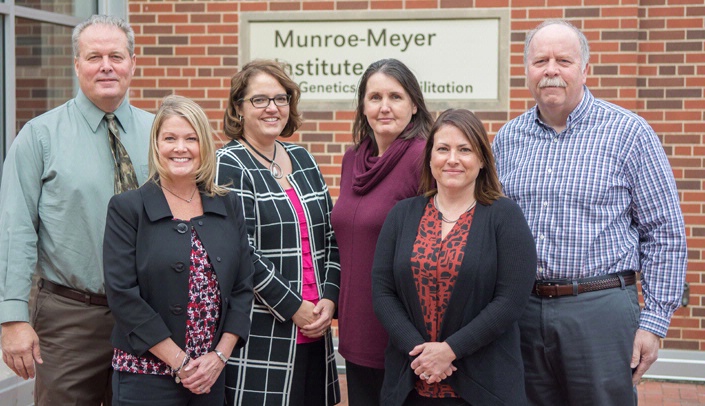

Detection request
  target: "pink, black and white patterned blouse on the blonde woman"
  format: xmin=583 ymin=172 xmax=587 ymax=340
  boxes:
xmin=113 ymin=227 xmax=220 ymax=375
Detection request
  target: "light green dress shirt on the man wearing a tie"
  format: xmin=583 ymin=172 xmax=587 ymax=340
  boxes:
xmin=0 ymin=91 xmax=154 ymax=323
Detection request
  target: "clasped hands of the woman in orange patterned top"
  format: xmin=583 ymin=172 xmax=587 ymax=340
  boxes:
xmin=409 ymin=342 xmax=458 ymax=384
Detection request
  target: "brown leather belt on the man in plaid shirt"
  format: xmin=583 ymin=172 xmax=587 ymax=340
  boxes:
xmin=533 ymin=271 xmax=636 ymax=297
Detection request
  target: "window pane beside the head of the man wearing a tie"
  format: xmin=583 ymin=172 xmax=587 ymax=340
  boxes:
xmin=15 ymin=18 xmax=75 ymax=132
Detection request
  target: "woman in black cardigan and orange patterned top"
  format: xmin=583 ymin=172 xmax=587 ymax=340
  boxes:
xmin=372 ymin=110 xmax=536 ymax=406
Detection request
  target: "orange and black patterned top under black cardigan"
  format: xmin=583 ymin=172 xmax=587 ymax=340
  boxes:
xmin=411 ymin=198 xmax=475 ymax=398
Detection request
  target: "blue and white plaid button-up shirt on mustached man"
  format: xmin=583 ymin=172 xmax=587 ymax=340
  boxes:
xmin=492 ymin=87 xmax=686 ymax=337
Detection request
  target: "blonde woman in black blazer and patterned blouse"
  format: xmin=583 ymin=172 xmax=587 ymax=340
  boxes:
xmin=103 ymin=96 xmax=253 ymax=405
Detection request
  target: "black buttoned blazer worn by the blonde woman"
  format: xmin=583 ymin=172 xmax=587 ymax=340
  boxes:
xmin=103 ymin=181 xmax=253 ymax=356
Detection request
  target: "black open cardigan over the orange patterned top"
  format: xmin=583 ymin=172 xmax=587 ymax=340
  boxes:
xmin=372 ymin=196 xmax=536 ymax=406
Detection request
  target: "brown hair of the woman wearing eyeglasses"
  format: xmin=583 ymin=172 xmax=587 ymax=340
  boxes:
xmin=223 ymin=59 xmax=301 ymax=140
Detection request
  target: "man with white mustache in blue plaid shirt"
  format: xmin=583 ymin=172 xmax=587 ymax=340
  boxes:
xmin=493 ymin=20 xmax=686 ymax=406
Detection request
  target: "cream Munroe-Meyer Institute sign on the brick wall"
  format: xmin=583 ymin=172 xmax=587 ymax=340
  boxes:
xmin=240 ymin=10 xmax=509 ymax=110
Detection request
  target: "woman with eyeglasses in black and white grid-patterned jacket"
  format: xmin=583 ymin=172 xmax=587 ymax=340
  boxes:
xmin=216 ymin=60 xmax=340 ymax=406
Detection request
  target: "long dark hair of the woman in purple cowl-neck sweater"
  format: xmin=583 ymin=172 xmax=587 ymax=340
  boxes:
xmin=353 ymin=58 xmax=433 ymax=155
